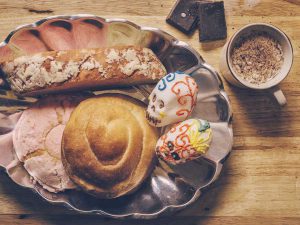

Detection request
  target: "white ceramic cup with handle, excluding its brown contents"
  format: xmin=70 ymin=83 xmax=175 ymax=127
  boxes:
xmin=220 ymin=23 xmax=293 ymax=106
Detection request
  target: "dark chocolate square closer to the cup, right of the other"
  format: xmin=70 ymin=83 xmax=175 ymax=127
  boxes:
xmin=198 ymin=1 xmax=227 ymax=41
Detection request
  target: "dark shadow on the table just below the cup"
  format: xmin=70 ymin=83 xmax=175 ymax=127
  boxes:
xmin=228 ymin=81 xmax=295 ymax=137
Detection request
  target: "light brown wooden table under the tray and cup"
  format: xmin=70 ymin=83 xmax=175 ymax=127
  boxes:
xmin=0 ymin=0 xmax=300 ymax=225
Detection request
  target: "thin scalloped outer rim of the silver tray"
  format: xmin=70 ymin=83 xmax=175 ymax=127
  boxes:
xmin=0 ymin=14 xmax=233 ymax=219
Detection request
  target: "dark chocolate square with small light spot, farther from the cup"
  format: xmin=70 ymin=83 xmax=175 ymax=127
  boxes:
xmin=166 ymin=0 xmax=198 ymax=34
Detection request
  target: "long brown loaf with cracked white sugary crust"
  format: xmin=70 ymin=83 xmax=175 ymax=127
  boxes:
xmin=0 ymin=46 xmax=166 ymax=96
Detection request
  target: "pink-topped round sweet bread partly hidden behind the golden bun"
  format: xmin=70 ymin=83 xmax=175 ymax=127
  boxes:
xmin=13 ymin=95 xmax=84 ymax=192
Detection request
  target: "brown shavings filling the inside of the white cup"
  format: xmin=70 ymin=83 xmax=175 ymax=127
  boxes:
xmin=231 ymin=33 xmax=283 ymax=85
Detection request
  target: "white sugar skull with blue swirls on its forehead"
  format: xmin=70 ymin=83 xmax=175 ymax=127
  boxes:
xmin=146 ymin=72 xmax=198 ymax=127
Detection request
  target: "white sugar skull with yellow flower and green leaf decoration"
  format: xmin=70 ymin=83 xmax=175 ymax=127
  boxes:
xmin=155 ymin=119 xmax=212 ymax=165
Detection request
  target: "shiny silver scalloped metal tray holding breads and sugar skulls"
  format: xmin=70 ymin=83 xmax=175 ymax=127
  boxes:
xmin=0 ymin=15 xmax=233 ymax=218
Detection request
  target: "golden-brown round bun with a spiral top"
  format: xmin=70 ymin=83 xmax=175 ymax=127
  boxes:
xmin=62 ymin=95 xmax=158 ymax=198
